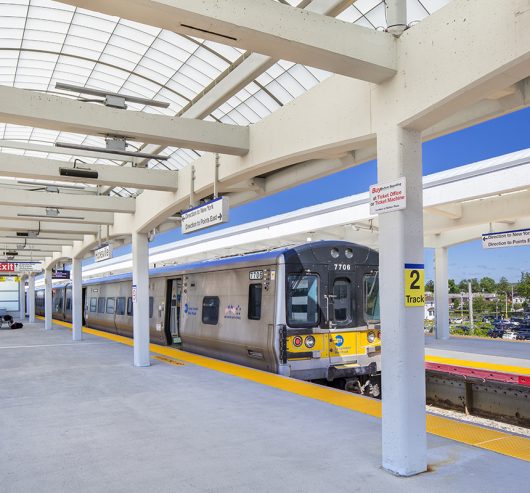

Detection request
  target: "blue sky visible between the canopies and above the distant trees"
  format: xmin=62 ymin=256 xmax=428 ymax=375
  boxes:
xmin=100 ymin=108 xmax=530 ymax=282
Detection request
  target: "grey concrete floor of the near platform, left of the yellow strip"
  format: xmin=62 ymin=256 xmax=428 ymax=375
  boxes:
xmin=0 ymin=323 xmax=530 ymax=493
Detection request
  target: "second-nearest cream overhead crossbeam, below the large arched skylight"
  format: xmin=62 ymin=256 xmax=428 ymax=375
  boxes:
xmin=0 ymin=86 xmax=248 ymax=155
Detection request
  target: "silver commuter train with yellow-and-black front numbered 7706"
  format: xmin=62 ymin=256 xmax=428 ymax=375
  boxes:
xmin=35 ymin=241 xmax=381 ymax=395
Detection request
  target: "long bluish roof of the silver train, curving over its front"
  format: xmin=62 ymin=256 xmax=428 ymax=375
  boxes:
xmin=43 ymin=240 xmax=378 ymax=288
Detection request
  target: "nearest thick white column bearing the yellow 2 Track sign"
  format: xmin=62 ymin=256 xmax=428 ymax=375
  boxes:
xmin=377 ymin=126 xmax=427 ymax=476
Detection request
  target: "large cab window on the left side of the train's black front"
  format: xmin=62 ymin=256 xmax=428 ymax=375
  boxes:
xmin=287 ymin=274 xmax=318 ymax=327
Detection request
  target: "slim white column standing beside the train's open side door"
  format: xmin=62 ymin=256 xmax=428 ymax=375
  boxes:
xmin=132 ymin=232 xmax=150 ymax=366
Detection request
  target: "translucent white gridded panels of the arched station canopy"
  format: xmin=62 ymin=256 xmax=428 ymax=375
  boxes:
xmin=0 ymin=0 xmax=449 ymax=196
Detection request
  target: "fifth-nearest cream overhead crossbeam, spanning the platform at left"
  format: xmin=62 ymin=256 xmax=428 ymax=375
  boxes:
xmin=0 ymin=204 xmax=114 ymax=228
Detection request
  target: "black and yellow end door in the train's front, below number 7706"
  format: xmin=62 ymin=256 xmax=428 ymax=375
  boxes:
xmin=324 ymin=270 xmax=357 ymax=364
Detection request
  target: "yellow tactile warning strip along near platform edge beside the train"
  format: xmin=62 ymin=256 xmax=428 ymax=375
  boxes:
xmin=38 ymin=317 xmax=530 ymax=462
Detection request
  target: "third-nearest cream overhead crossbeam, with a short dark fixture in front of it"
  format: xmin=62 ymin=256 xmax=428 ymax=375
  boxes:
xmin=0 ymin=153 xmax=178 ymax=191
